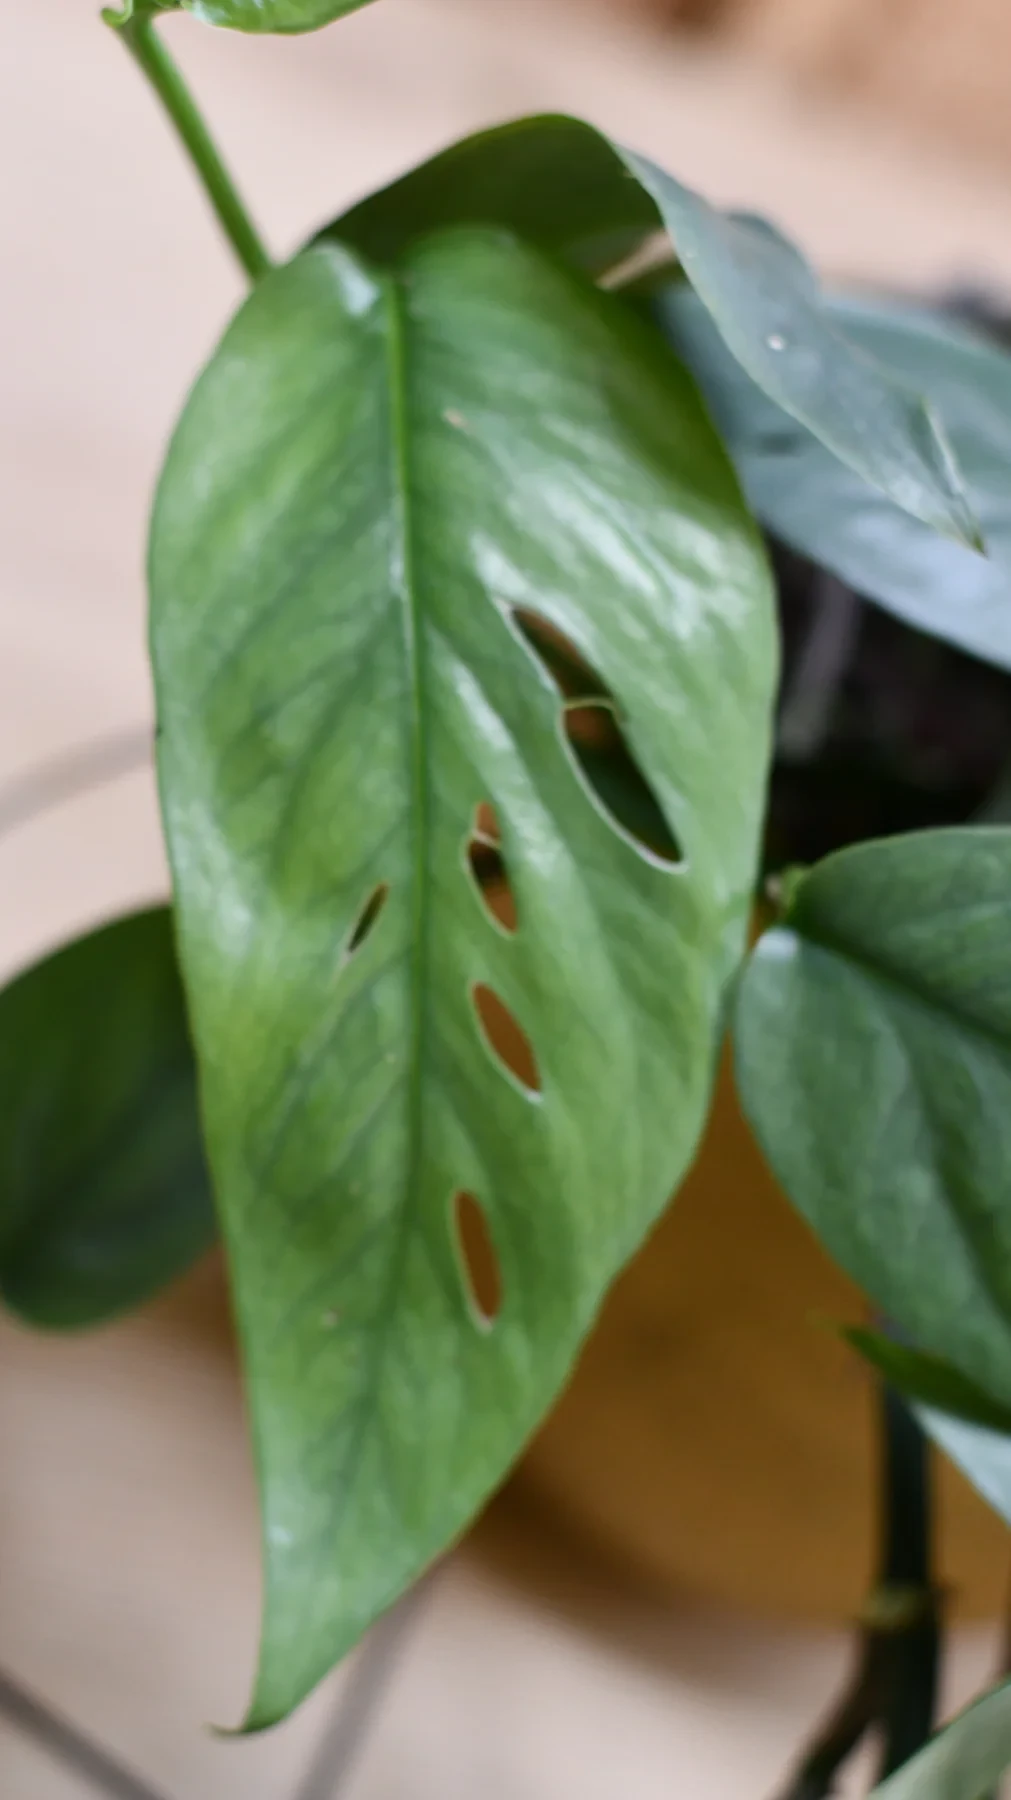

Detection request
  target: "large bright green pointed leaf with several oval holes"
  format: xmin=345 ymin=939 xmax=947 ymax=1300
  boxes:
xmin=151 ymin=232 xmax=775 ymax=1726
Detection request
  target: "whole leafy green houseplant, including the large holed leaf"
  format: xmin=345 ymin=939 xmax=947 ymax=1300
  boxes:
xmin=0 ymin=0 xmax=1011 ymax=1778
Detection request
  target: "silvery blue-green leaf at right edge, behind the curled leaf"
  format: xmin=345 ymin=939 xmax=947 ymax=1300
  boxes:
xmin=655 ymin=284 xmax=1011 ymax=668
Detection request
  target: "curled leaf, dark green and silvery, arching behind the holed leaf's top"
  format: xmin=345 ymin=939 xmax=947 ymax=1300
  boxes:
xmin=320 ymin=117 xmax=980 ymax=547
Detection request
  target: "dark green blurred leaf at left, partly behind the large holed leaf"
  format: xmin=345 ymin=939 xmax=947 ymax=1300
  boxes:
xmin=0 ymin=907 xmax=214 ymax=1328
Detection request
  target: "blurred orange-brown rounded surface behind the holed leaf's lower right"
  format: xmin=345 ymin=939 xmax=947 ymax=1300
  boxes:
xmin=518 ymin=1073 xmax=1009 ymax=1620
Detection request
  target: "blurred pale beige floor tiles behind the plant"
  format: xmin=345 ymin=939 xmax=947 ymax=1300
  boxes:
xmin=0 ymin=0 xmax=1011 ymax=1800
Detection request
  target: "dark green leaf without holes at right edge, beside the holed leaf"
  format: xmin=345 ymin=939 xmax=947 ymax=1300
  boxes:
xmin=736 ymin=828 xmax=1011 ymax=1406
